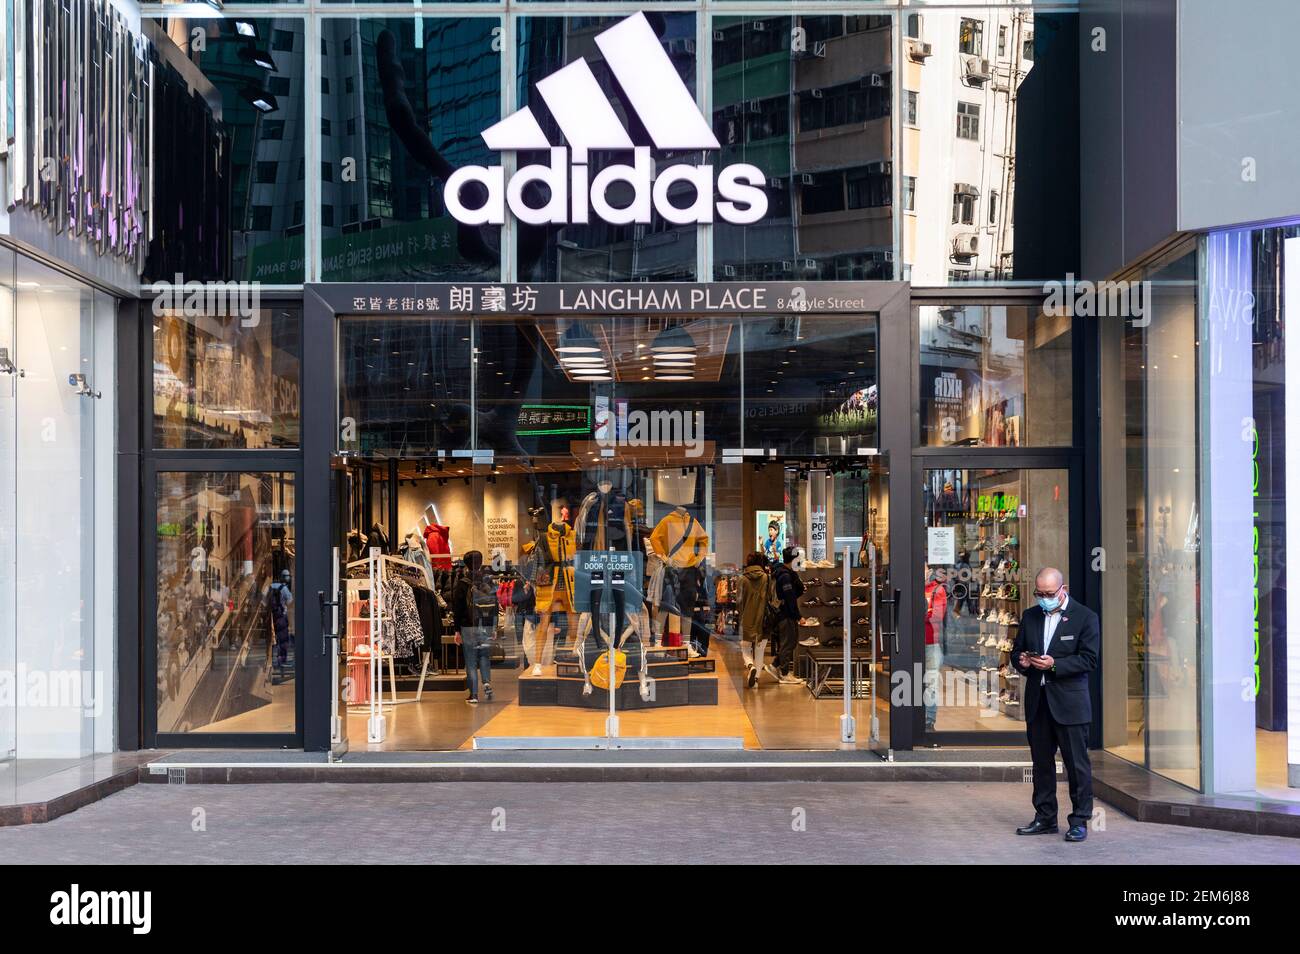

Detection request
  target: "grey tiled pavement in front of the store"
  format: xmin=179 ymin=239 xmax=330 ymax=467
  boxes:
xmin=0 ymin=782 xmax=1300 ymax=864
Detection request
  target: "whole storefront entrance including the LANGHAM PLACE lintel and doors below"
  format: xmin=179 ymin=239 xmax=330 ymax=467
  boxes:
xmin=303 ymin=283 xmax=909 ymax=754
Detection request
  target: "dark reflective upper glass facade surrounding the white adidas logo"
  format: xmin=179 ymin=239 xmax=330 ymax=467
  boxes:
xmin=137 ymin=3 xmax=1079 ymax=286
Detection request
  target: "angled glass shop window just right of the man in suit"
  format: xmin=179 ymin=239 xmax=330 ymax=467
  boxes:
xmin=1102 ymin=246 xmax=1204 ymax=788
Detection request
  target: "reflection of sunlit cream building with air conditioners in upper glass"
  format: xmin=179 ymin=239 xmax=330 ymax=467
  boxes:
xmin=900 ymin=8 xmax=1034 ymax=285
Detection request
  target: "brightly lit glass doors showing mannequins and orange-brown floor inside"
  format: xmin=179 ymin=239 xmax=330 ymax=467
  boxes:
xmin=325 ymin=452 xmax=893 ymax=750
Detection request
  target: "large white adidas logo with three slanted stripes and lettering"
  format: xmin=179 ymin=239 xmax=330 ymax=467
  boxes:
xmin=443 ymin=13 xmax=767 ymax=225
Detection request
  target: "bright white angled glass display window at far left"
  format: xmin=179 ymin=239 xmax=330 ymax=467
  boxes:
xmin=0 ymin=248 xmax=117 ymax=785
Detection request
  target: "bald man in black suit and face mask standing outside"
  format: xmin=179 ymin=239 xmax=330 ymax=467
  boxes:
xmin=1011 ymin=567 xmax=1101 ymax=841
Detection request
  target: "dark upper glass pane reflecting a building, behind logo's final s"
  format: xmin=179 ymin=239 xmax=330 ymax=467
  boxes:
xmin=714 ymin=16 xmax=893 ymax=279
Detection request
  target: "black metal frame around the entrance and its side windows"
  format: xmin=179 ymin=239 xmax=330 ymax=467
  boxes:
xmin=137 ymin=282 xmax=1101 ymax=751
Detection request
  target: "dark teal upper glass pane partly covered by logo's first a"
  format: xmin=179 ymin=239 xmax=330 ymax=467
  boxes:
xmin=321 ymin=17 xmax=501 ymax=281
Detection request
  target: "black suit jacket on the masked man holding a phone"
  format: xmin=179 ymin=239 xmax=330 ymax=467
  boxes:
xmin=1011 ymin=597 xmax=1101 ymax=725
